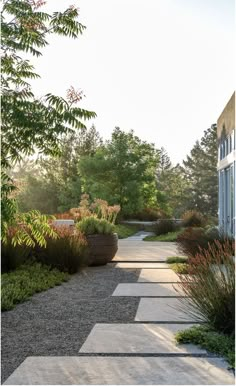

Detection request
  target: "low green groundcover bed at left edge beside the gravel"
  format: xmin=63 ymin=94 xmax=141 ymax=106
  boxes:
xmin=1 ymin=263 xmax=69 ymax=311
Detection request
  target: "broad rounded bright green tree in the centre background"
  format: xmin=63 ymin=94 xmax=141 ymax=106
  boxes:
xmin=79 ymin=128 xmax=158 ymax=214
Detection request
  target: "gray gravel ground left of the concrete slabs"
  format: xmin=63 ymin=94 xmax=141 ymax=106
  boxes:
xmin=1 ymin=266 xmax=140 ymax=382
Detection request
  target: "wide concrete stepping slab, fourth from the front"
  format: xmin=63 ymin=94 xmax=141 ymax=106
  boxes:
xmin=112 ymin=283 xmax=184 ymax=297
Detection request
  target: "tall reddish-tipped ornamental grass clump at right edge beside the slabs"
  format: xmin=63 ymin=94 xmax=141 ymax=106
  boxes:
xmin=179 ymin=241 xmax=235 ymax=334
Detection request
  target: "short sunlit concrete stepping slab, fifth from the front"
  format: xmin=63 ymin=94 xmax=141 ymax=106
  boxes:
xmin=138 ymin=269 xmax=180 ymax=283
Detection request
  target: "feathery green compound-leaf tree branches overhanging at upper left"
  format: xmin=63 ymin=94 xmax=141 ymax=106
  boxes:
xmin=1 ymin=0 xmax=96 ymax=237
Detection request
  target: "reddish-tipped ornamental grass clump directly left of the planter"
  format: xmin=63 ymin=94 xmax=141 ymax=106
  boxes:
xmin=33 ymin=226 xmax=87 ymax=274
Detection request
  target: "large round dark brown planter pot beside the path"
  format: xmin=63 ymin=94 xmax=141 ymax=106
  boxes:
xmin=86 ymin=233 xmax=118 ymax=266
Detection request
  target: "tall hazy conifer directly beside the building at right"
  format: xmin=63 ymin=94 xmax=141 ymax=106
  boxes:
xmin=183 ymin=124 xmax=218 ymax=216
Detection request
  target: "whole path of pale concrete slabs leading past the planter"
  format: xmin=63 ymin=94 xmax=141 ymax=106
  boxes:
xmin=2 ymin=233 xmax=234 ymax=385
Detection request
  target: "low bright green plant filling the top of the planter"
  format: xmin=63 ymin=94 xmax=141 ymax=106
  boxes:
xmin=76 ymin=216 xmax=115 ymax=235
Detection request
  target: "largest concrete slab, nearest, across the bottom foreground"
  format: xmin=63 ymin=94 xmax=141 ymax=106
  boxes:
xmin=4 ymin=356 xmax=234 ymax=385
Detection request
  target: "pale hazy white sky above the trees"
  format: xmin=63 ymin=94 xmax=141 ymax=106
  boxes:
xmin=30 ymin=0 xmax=235 ymax=162
